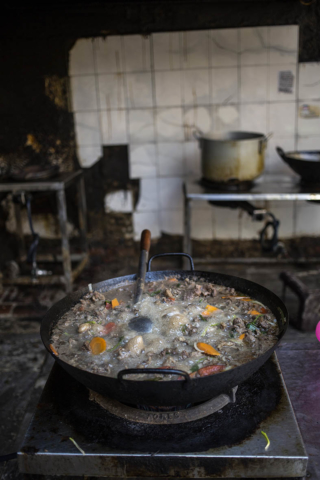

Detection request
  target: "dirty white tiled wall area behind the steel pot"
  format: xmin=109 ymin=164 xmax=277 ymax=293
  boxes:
xmin=69 ymin=25 xmax=320 ymax=239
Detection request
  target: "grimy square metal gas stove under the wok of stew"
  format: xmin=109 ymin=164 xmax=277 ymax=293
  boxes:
xmin=18 ymin=354 xmax=308 ymax=479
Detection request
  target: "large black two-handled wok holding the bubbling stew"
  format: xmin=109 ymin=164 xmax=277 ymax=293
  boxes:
xmin=41 ymin=253 xmax=288 ymax=406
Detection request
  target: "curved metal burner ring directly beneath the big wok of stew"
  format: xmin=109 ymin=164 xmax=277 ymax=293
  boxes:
xmin=90 ymin=387 xmax=238 ymax=425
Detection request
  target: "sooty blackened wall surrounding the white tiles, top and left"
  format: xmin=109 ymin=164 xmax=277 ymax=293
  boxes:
xmin=0 ymin=0 xmax=320 ymax=248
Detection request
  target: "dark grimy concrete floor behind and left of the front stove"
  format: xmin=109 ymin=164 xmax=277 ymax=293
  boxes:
xmin=0 ymin=260 xmax=318 ymax=480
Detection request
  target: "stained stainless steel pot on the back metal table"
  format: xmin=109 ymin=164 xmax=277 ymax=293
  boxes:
xmin=194 ymin=131 xmax=270 ymax=184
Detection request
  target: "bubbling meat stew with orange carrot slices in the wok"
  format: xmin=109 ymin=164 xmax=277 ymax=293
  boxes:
xmin=51 ymin=276 xmax=279 ymax=380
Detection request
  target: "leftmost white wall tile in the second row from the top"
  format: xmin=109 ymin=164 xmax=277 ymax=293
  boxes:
xmin=70 ymin=75 xmax=98 ymax=112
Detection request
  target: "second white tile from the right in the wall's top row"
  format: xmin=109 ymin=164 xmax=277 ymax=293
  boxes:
xmin=240 ymin=27 xmax=268 ymax=65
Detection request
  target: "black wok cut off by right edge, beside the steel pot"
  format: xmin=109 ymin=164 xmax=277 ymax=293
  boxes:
xmin=276 ymin=147 xmax=320 ymax=183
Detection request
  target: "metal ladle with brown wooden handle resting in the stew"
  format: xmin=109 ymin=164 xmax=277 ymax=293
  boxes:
xmin=128 ymin=230 xmax=153 ymax=333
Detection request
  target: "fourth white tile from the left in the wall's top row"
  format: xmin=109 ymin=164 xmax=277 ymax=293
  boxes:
xmin=152 ymin=32 xmax=181 ymax=70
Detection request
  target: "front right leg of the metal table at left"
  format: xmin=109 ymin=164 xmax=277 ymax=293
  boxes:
xmin=57 ymin=190 xmax=72 ymax=293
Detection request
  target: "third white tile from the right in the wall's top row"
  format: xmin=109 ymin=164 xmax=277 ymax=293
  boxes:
xmin=209 ymin=28 xmax=239 ymax=67
